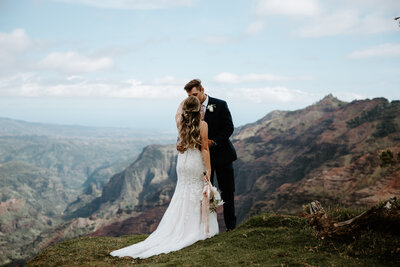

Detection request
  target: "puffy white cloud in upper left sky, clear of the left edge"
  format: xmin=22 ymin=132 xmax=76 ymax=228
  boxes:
xmin=38 ymin=51 xmax=114 ymax=74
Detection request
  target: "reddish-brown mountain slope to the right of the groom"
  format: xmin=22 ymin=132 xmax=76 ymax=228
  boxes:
xmin=232 ymin=96 xmax=400 ymax=219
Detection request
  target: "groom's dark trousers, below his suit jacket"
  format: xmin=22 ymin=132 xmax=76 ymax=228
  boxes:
xmin=210 ymin=162 xmax=236 ymax=229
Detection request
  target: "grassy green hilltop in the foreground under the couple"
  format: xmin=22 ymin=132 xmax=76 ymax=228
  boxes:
xmin=27 ymin=214 xmax=400 ymax=266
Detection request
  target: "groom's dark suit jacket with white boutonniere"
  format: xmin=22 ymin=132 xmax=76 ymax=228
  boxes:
xmin=204 ymin=96 xmax=237 ymax=166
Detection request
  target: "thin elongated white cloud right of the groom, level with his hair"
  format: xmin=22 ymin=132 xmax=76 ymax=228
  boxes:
xmin=214 ymin=72 xmax=312 ymax=84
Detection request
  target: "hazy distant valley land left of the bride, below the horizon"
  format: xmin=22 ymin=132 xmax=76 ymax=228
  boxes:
xmin=0 ymin=116 xmax=175 ymax=265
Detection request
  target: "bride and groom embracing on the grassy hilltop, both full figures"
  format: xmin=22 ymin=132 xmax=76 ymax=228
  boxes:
xmin=110 ymin=79 xmax=237 ymax=258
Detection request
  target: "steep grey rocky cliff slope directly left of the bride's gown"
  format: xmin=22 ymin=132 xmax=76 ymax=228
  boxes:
xmin=68 ymin=145 xmax=177 ymax=221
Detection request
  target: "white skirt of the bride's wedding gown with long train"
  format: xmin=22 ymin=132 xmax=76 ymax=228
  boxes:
xmin=110 ymin=149 xmax=219 ymax=258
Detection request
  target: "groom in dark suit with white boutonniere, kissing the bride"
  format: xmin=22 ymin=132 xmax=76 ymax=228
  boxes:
xmin=178 ymin=79 xmax=237 ymax=231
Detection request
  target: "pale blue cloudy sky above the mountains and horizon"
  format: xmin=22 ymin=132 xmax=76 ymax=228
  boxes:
xmin=0 ymin=0 xmax=400 ymax=130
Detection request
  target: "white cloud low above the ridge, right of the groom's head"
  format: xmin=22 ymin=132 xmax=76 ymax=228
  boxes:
xmin=227 ymin=86 xmax=320 ymax=103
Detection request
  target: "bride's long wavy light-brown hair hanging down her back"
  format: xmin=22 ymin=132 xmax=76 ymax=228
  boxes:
xmin=179 ymin=96 xmax=201 ymax=149
